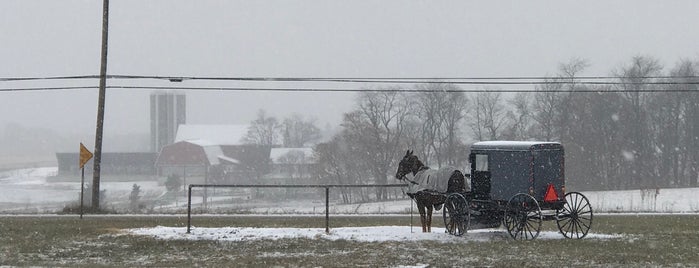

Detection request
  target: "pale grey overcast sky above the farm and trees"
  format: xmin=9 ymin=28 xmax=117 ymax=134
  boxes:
xmin=0 ymin=0 xmax=699 ymax=140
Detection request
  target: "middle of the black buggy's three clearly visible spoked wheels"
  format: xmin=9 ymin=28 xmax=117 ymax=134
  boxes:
xmin=503 ymin=193 xmax=543 ymax=240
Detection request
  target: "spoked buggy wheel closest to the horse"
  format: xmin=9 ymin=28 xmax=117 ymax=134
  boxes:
xmin=442 ymin=193 xmax=471 ymax=236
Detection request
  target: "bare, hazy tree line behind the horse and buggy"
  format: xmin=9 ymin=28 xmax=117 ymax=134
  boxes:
xmin=246 ymin=56 xmax=699 ymax=202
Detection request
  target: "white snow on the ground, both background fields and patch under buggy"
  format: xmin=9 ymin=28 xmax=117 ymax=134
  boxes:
xmin=0 ymin=168 xmax=699 ymax=262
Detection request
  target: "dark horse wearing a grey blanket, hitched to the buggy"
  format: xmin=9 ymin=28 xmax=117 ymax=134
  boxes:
xmin=396 ymin=150 xmax=467 ymax=233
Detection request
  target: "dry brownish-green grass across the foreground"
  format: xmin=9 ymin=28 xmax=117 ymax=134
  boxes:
xmin=0 ymin=215 xmax=699 ymax=267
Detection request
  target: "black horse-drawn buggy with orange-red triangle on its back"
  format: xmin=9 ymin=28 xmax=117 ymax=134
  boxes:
xmin=443 ymin=141 xmax=592 ymax=240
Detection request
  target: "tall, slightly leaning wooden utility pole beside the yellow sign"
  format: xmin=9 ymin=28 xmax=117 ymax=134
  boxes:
xmin=92 ymin=0 xmax=109 ymax=211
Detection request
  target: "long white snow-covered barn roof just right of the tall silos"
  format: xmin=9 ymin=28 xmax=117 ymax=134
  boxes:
xmin=175 ymin=124 xmax=248 ymax=146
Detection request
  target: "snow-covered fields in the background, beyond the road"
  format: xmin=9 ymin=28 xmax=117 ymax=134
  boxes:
xmin=0 ymin=167 xmax=699 ymax=214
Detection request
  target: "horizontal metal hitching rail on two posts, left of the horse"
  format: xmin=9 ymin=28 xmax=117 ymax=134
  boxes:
xmin=187 ymin=184 xmax=408 ymax=233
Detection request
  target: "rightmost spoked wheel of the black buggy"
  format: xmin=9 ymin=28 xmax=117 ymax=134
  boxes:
xmin=556 ymin=192 xmax=592 ymax=239
